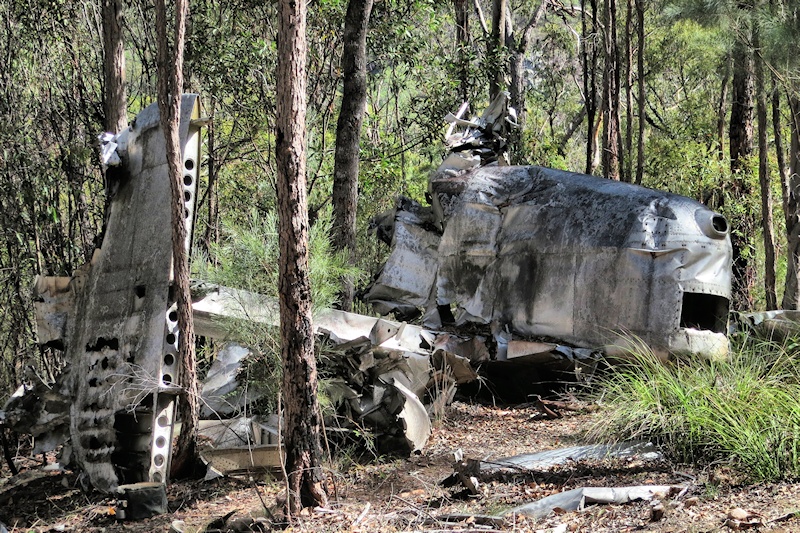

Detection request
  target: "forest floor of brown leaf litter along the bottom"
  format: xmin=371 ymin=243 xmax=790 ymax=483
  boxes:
xmin=0 ymin=402 xmax=800 ymax=533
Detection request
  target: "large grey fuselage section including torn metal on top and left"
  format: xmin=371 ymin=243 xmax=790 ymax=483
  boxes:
xmin=365 ymin=95 xmax=731 ymax=360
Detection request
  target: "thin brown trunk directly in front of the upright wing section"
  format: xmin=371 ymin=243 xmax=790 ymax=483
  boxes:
xmin=155 ymin=0 xmax=200 ymax=477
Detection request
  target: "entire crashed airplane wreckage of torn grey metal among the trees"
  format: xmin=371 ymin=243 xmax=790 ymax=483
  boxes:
xmin=0 ymin=95 xmax=731 ymax=518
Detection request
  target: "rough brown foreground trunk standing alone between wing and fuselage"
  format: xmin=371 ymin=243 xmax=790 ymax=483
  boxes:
xmin=275 ymin=0 xmax=327 ymax=516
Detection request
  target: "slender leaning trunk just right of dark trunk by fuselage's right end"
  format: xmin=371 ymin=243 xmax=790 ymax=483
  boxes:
xmin=753 ymin=29 xmax=778 ymax=311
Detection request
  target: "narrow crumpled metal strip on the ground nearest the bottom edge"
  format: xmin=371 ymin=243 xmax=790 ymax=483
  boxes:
xmin=504 ymin=485 xmax=682 ymax=519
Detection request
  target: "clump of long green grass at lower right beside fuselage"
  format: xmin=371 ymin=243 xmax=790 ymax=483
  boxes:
xmin=589 ymin=337 xmax=800 ymax=481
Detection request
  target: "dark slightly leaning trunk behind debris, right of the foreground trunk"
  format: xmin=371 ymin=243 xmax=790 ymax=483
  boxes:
xmin=333 ymin=0 xmax=373 ymax=311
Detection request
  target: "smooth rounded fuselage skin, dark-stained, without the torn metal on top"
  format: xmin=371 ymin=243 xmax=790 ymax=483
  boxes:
xmin=431 ymin=167 xmax=731 ymax=358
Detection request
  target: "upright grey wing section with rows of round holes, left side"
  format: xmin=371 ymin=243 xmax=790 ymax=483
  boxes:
xmin=66 ymin=95 xmax=200 ymax=491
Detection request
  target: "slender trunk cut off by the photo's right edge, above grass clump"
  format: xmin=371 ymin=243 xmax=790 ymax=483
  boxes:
xmin=782 ymin=94 xmax=800 ymax=309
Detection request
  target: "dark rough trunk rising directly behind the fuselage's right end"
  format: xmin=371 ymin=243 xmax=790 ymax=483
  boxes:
xmin=728 ymin=37 xmax=756 ymax=311
